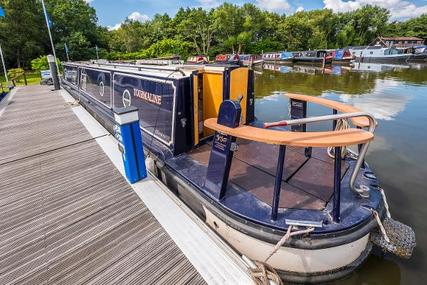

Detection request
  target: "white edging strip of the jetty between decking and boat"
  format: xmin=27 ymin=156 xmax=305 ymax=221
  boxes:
xmin=61 ymin=90 xmax=254 ymax=285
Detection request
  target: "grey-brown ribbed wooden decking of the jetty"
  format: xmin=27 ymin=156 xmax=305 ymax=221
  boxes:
xmin=0 ymin=86 xmax=205 ymax=284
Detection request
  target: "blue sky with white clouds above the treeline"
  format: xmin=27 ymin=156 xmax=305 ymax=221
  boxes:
xmin=85 ymin=0 xmax=427 ymax=29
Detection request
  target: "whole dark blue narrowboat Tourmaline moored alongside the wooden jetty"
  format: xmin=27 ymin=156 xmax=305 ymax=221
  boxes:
xmin=62 ymin=63 xmax=415 ymax=282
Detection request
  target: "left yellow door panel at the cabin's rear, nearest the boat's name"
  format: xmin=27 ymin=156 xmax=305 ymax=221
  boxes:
xmin=203 ymin=72 xmax=223 ymax=136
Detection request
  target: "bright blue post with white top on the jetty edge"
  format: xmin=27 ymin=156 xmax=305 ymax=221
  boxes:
xmin=114 ymin=106 xmax=147 ymax=183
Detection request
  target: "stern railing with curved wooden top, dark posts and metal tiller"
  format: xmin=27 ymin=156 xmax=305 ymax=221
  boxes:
xmin=204 ymin=95 xmax=377 ymax=222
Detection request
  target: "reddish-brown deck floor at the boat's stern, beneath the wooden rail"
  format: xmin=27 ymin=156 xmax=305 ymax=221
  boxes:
xmin=174 ymin=140 xmax=349 ymax=210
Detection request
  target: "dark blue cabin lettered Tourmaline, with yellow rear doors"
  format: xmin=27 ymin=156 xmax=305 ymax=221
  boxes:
xmin=63 ymin=63 xmax=255 ymax=157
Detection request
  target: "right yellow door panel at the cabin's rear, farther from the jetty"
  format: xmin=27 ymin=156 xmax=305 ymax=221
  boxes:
xmin=230 ymin=67 xmax=249 ymax=124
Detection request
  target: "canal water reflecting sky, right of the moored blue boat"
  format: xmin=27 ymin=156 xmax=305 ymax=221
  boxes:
xmin=255 ymin=63 xmax=427 ymax=285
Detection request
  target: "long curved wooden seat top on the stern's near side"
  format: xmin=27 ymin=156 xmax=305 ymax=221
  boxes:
xmin=204 ymin=118 xmax=374 ymax=147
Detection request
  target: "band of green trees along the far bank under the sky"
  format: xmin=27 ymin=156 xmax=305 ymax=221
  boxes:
xmin=0 ymin=0 xmax=427 ymax=70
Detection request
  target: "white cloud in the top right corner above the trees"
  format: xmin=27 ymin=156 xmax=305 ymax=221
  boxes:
xmin=323 ymin=0 xmax=427 ymax=20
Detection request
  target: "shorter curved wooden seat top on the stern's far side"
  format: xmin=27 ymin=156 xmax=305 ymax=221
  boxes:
xmin=286 ymin=93 xmax=369 ymax=128
